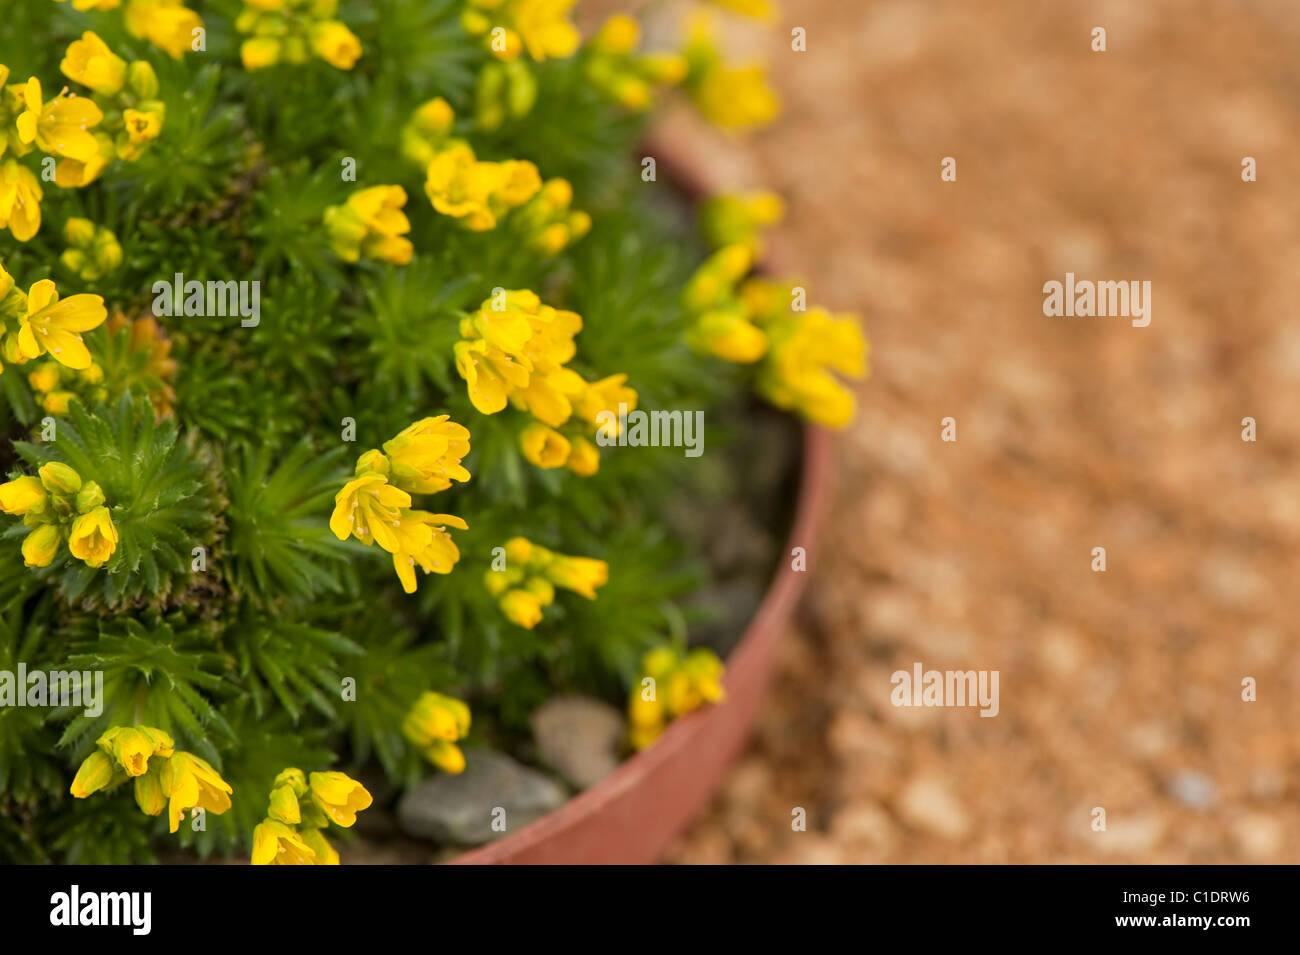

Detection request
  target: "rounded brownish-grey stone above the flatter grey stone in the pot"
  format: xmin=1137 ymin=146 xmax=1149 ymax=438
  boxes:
xmin=530 ymin=696 xmax=624 ymax=789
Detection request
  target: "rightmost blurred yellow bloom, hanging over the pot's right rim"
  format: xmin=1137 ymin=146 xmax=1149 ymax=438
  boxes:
xmin=758 ymin=308 xmax=867 ymax=427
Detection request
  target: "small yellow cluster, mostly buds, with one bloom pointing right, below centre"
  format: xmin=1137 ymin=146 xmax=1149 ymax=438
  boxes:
xmin=484 ymin=537 xmax=610 ymax=630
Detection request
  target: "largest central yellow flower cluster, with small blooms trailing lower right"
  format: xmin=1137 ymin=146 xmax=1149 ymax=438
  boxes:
xmin=455 ymin=290 xmax=637 ymax=476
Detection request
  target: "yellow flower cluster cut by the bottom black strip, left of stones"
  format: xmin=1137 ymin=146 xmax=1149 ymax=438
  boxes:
xmin=252 ymin=767 xmax=374 ymax=865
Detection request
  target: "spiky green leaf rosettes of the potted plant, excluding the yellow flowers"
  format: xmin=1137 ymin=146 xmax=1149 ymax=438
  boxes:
xmin=0 ymin=0 xmax=759 ymax=863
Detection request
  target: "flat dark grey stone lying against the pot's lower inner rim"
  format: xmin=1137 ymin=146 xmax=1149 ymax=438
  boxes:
xmin=398 ymin=750 xmax=568 ymax=846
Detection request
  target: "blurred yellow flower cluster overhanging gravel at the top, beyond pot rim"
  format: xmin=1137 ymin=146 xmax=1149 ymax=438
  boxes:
xmin=684 ymin=16 xmax=781 ymax=130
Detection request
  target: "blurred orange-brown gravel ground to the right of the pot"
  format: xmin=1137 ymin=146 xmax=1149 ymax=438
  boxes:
xmin=616 ymin=0 xmax=1300 ymax=863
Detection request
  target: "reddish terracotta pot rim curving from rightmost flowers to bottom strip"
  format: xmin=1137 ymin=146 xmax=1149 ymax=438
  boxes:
xmin=449 ymin=425 xmax=833 ymax=865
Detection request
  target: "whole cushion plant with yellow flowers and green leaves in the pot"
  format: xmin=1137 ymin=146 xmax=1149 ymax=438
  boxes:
xmin=0 ymin=0 xmax=866 ymax=864
